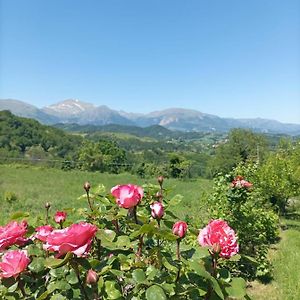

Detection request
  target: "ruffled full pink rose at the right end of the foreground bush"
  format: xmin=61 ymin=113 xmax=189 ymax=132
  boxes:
xmin=198 ymin=220 xmax=239 ymax=258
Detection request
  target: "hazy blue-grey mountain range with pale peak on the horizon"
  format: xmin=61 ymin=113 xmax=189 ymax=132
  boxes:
xmin=0 ymin=99 xmax=300 ymax=135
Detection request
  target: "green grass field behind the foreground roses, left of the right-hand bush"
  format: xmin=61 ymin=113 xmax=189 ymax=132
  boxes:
xmin=0 ymin=165 xmax=211 ymax=224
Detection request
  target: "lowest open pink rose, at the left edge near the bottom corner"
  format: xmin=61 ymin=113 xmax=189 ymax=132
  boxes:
xmin=0 ymin=250 xmax=30 ymax=278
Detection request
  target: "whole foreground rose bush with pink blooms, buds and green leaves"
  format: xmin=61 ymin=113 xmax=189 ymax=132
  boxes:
xmin=0 ymin=178 xmax=246 ymax=300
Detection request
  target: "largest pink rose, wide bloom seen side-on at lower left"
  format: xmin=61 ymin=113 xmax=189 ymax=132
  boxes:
xmin=44 ymin=222 xmax=97 ymax=256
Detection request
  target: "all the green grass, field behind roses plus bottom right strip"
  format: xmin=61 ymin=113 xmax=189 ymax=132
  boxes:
xmin=0 ymin=165 xmax=300 ymax=300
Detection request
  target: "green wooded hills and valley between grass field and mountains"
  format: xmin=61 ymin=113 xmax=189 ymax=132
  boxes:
xmin=0 ymin=111 xmax=298 ymax=183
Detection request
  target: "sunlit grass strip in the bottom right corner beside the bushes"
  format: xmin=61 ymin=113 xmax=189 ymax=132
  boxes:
xmin=249 ymin=214 xmax=300 ymax=300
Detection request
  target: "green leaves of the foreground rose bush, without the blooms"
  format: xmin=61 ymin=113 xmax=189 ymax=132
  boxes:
xmin=0 ymin=179 xmax=248 ymax=300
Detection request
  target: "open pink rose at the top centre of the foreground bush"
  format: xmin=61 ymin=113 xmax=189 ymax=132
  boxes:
xmin=111 ymin=184 xmax=144 ymax=208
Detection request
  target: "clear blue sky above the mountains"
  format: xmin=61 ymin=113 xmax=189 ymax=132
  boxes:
xmin=0 ymin=0 xmax=300 ymax=123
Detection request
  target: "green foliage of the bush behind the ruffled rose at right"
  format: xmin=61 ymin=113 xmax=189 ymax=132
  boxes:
xmin=208 ymin=164 xmax=279 ymax=279
